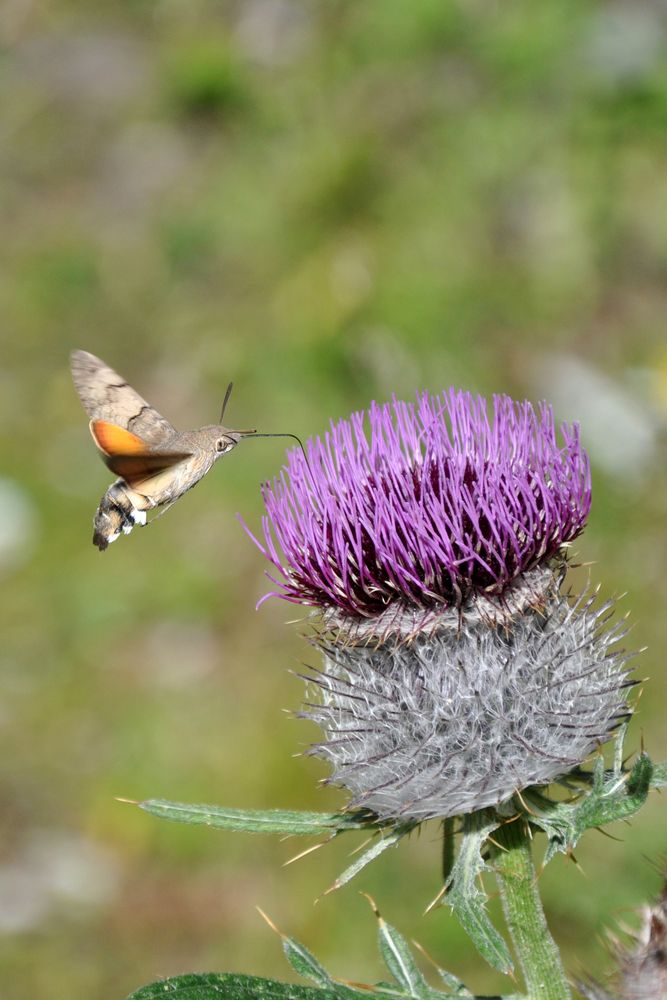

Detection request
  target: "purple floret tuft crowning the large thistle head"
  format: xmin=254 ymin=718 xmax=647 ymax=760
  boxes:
xmin=248 ymin=389 xmax=591 ymax=617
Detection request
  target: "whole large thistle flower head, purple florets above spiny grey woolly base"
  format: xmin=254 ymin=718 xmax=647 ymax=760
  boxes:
xmin=249 ymin=390 xmax=628 ymax=820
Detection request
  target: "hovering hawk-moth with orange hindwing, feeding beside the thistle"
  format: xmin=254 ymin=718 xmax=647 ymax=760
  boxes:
xmin=71 ymin=351 xmax=255 ymax=551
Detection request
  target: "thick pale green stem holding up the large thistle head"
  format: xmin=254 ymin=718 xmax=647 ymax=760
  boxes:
xmin=493 ymin=818 xmax=572 ymax=1000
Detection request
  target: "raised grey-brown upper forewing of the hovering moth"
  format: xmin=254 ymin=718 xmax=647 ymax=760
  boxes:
xmin=70 ymin=351 xmax=176 ymax=446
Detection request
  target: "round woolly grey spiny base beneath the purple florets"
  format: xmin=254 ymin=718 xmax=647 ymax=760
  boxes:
xmin=302 ymin=579 xmax=628 ymax=820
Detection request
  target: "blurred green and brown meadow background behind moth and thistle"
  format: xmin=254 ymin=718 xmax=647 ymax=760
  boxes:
xmin=0 ymin=0 xmax=667 ymax=1000
